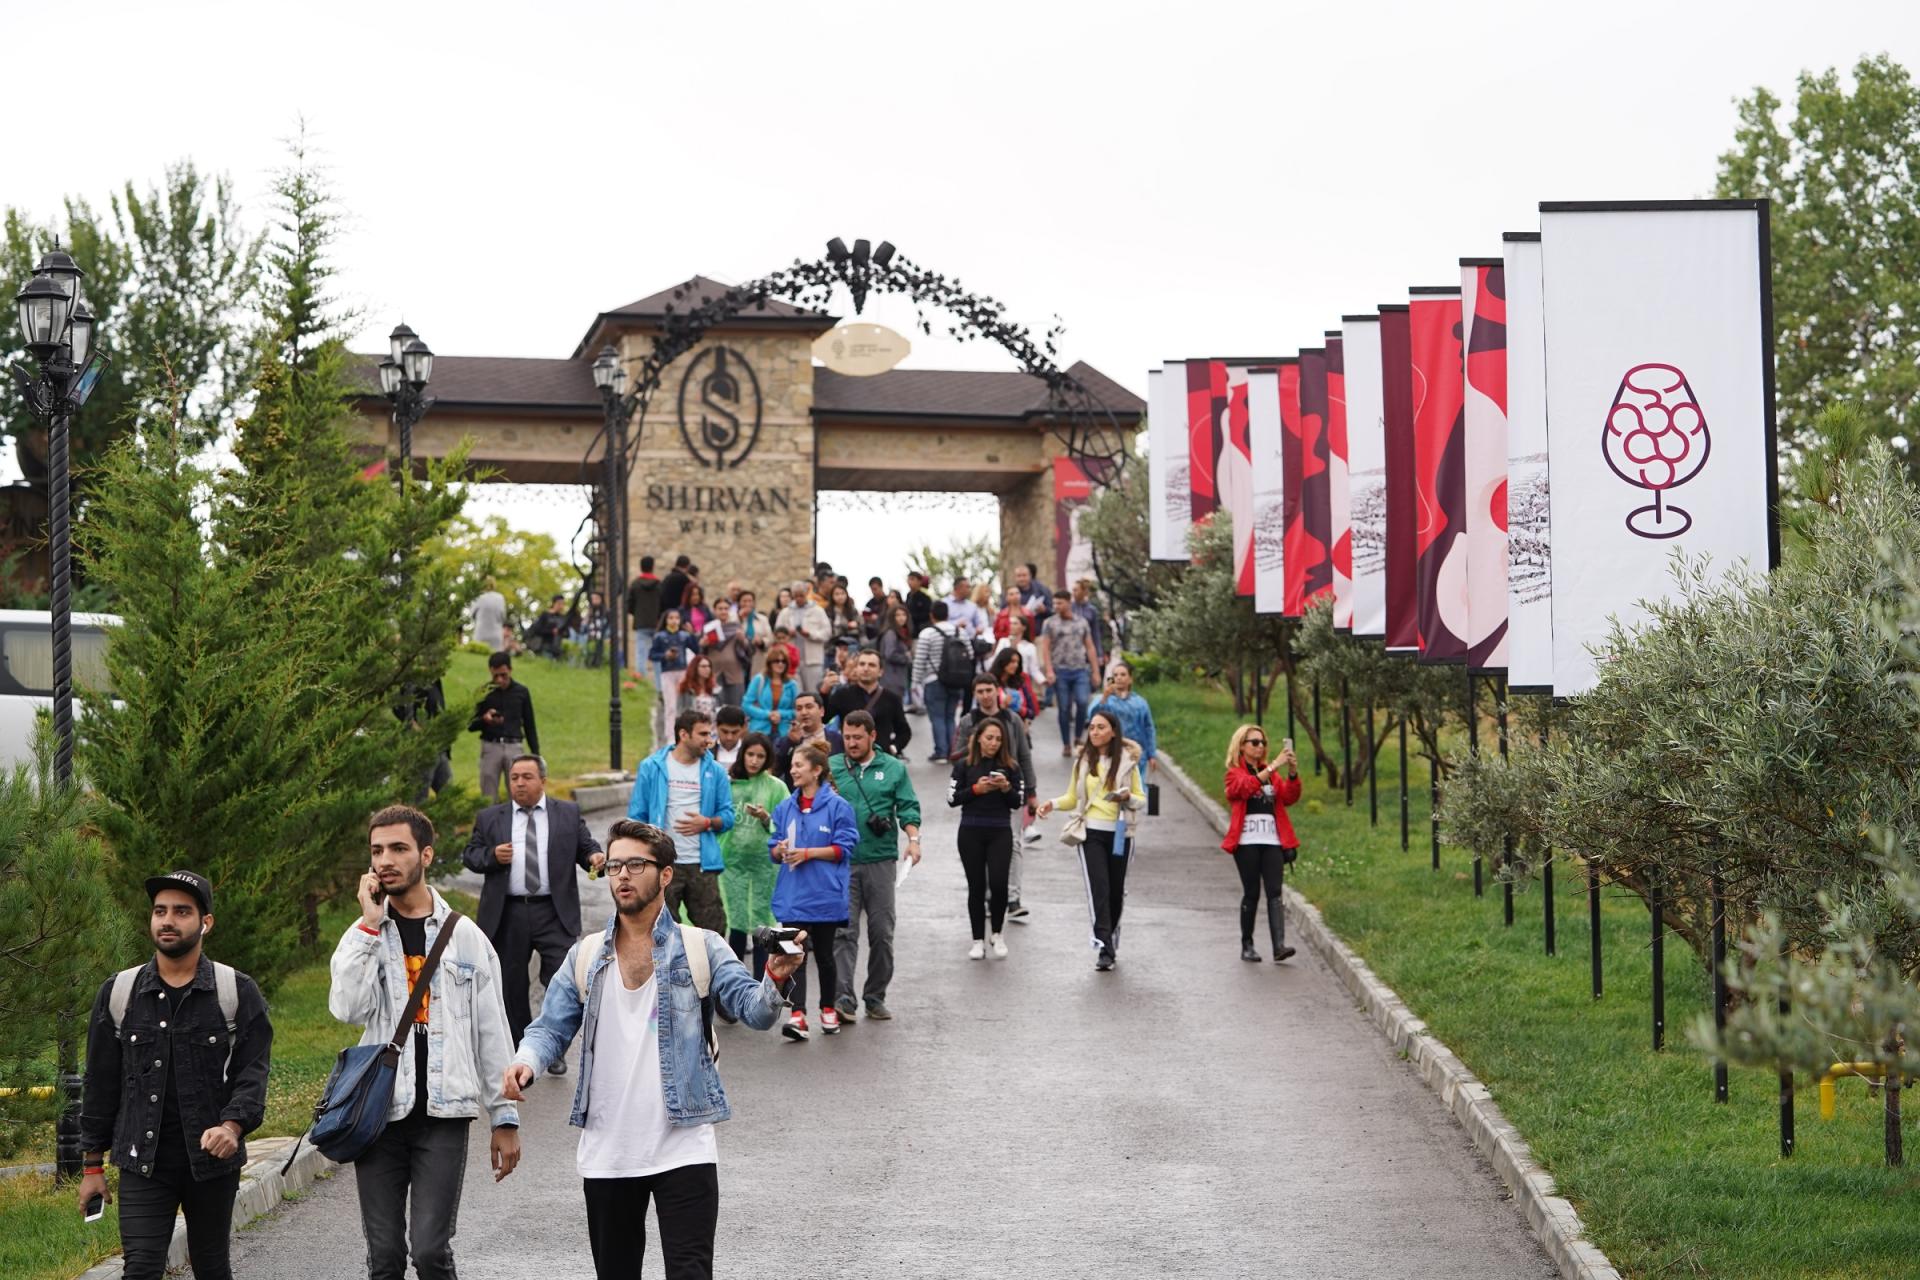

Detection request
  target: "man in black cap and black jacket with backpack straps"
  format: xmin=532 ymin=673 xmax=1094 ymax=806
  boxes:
xmin=79 ymin=871 xmax=273 ymax=1280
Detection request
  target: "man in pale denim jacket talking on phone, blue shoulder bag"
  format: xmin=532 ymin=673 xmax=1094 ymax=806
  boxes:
xmin=326 ymin=804 xmax=520 ymax=1280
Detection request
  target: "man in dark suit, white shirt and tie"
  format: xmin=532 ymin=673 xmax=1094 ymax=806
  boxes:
xmin=461 ymin=756 xmax=607 ymax=1075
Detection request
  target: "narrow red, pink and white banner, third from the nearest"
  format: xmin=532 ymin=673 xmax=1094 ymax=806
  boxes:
xmin=1459 ymin=257 xmax=1507 ymax=674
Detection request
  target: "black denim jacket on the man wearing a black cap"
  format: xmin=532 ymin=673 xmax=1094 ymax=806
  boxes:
xmin=81 ymin=956 xmax=273 ymax=1182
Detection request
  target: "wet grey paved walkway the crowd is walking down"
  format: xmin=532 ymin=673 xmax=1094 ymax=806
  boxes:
xmin=234 ymin=736 xmax=1553 ymax=1280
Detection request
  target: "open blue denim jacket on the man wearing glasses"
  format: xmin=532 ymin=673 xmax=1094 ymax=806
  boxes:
xmin=513 ymin=910 xmax=781 ymax=1128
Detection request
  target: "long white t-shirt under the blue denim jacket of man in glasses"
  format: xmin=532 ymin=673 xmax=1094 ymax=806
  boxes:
xmin=574 ymin=982 xmax=720 ymax=1178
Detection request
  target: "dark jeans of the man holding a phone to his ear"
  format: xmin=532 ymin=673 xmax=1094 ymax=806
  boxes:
xmin=353 ymin=1115 xmax=472 ymax=1280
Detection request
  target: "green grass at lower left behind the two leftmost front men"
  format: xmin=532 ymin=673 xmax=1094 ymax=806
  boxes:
xmin=0 ymin=889 xmax=480 ymax=1280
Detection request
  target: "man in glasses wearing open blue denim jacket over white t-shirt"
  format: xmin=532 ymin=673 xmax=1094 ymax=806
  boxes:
xmin=501 ymin=819 xmax=806 ymax=1280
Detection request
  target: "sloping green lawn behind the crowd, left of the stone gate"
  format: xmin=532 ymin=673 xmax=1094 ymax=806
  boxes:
xmin=444 ymin=649 xmax=653 ymax=796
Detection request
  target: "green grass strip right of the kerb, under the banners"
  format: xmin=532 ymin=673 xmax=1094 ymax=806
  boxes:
xmin=1144 ymin=683 xmax=1920 ymax=1280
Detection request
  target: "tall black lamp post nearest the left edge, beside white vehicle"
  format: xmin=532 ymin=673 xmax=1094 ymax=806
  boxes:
xmin=8 ymin=246 xmax=106 ymax=1178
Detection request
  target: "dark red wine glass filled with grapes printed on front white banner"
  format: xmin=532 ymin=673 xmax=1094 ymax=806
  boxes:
xmin=1599 ymin=365 xmax=1713 ymax=537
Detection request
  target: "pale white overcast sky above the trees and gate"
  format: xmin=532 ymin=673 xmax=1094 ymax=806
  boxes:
xmin=18 ymin=0 xmax=1920 ymax=578
